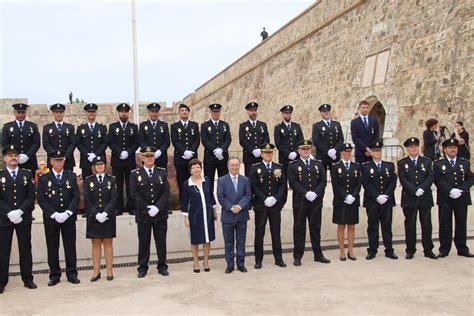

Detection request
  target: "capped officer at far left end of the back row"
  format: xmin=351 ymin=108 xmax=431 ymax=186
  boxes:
xmin=2 ymin=103 xmax=41 ymax=174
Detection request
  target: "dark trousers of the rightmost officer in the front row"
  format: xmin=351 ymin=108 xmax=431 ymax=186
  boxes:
xmin=439 ymin=205 xmax=469 ymax=254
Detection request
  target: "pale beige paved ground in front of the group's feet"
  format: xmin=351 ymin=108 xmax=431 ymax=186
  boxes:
xmin=0 ymin=240 xmax=474 ymax=315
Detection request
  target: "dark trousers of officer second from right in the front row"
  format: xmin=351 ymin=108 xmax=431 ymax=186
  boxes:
xmin=403 ymin=207 xmax=434 ymax=254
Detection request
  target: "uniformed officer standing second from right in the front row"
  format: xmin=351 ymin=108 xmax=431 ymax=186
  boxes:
xmin=397 ymin=137 xmax=438 ymax=259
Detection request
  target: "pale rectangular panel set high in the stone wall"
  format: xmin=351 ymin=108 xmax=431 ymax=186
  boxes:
xmin=362 ymin=49 xmax=390 ymax=87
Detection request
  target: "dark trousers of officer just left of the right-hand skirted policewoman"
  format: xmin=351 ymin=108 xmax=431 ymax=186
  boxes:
xmin=293 ymin=205 xmax=322 ymax=259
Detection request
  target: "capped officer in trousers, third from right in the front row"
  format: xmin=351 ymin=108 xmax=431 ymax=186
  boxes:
xmin=362 ymin=140 xmax=398 ymax=260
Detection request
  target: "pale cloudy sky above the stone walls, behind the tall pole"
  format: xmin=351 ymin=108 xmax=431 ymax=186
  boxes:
xmin=0 ymin=0 xmax=313 ymax=104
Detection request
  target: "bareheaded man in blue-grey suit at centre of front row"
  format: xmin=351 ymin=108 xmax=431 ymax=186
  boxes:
xmin=217 ymin=157 xmax=252 ymax=274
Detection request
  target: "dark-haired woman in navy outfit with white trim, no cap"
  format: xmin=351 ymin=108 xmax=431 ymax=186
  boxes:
xmin=181 ymin=159 xmax=217 ymax=273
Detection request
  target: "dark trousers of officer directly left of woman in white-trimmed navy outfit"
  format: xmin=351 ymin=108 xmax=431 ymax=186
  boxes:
xmin=137 ymin=219 xmax=168 ymax=272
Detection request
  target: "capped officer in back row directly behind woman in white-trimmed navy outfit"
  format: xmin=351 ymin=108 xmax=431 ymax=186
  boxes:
xmin=171 ymin=103 xmax=201 ymax=201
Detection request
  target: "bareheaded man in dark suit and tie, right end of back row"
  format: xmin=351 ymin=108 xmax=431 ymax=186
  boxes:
xmin=351 ymin=100 xmax=379 ymax=163
